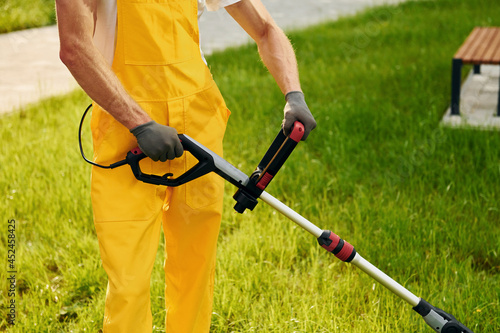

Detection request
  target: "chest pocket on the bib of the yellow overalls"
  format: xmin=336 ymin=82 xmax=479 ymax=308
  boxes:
xmin=119 ymin=0 xmax=199 ymax=65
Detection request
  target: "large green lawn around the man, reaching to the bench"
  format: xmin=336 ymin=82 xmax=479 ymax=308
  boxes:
xmin=0 ymin=0 xmax=500 ymax=333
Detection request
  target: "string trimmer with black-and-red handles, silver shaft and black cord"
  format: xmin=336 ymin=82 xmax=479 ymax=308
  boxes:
xmin=80 ymin=107 xmax=472 ymax=333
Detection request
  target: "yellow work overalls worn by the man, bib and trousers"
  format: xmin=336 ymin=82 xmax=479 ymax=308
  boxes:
xmin=91 ymin=0 xmax=229 ymax=333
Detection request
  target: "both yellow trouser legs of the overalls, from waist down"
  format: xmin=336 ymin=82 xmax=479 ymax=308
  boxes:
xmin=92 ymin=85 xmax=229 ymax=333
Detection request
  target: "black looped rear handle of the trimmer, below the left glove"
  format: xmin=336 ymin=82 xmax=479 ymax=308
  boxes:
xmin=125 ymin=134 xmax=216 ymax=187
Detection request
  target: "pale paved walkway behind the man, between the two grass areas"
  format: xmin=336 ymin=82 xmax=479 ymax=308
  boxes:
xmin=0 ymin=0 xmax=404 ymax=113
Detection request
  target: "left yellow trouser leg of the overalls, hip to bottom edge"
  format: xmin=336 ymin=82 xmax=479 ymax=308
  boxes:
xmin=91 ymin=107 xmax=168 ymax=333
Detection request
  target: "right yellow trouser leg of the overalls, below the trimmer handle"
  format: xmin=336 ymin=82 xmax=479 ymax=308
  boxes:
xmin=163 ymin=185 xmax=222 ymax=333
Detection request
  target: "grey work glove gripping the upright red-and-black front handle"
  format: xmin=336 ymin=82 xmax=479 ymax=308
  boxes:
xmin=281 ymin=91 xmax=316 ymax=141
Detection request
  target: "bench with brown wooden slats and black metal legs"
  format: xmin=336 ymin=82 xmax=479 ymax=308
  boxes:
xmin=451 ymin=27 xmax=500 ymax=116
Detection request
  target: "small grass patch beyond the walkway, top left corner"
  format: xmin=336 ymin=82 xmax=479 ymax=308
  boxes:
xmin=0 ymin=0 xmax=56 ymax=33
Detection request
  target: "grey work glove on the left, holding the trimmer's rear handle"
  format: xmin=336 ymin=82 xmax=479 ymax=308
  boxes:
xmin=130 ymin=120 xmax=184 ymax=162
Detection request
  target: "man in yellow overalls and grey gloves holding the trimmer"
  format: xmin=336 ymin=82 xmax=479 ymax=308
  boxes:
xmin=56 ymin=0 xmax=316 ymax=333
